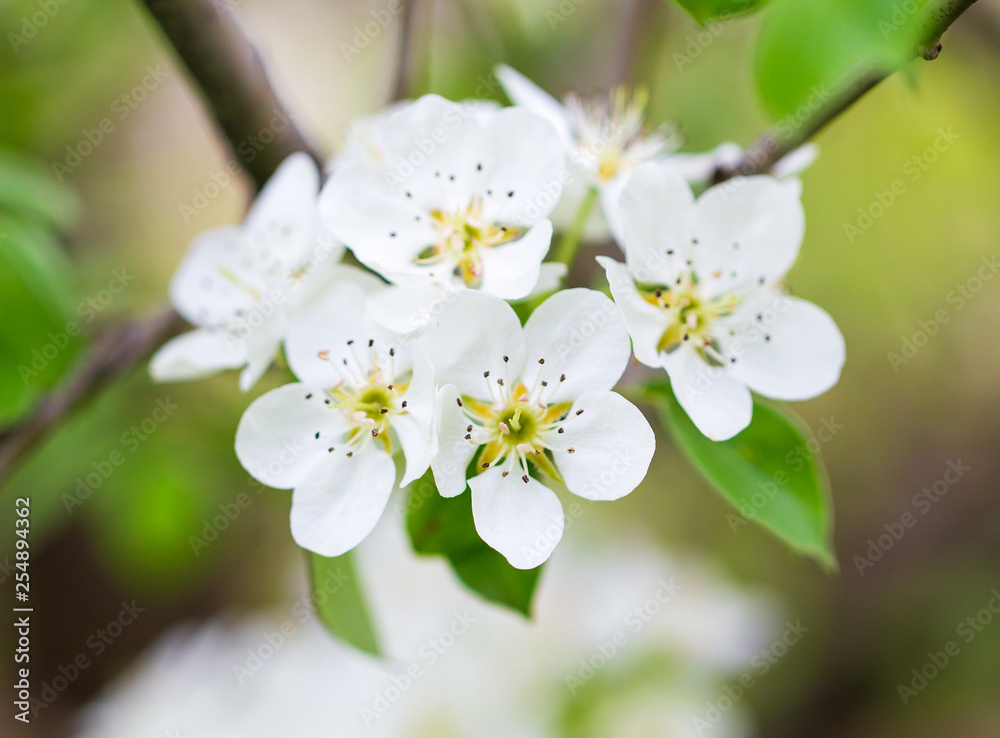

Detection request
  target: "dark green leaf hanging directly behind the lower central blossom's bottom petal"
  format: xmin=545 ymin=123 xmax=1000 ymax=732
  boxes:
xmin=406 ymin=472 xmax=542 ymax=617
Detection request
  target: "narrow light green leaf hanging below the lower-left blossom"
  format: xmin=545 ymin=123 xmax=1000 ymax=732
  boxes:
xmin=306 ymin=551 xmax=381 ymax=656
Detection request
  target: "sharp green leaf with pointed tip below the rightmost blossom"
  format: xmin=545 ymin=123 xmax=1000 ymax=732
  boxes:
xmin=645 ymin=380 xmax=836 ymax=569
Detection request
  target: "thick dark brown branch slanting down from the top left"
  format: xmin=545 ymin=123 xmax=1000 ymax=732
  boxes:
xmin=142 ymin=0 xmax=324 ymax=189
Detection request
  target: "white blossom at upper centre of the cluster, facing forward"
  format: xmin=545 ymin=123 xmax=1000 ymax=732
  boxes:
xmin=320 ymin=95 xmax=565 ymax=314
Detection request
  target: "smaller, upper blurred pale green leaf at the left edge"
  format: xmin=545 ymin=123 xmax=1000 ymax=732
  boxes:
xmin=0 ymin=149 xmax=77 ymax=229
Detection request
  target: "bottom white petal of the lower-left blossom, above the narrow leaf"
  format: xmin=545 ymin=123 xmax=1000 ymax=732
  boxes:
xmin=291 ymin=445 xmax=396 ymax=556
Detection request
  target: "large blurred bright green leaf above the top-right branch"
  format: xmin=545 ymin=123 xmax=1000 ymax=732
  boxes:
xmin=754 ymin=0 xmax=926 ymax=119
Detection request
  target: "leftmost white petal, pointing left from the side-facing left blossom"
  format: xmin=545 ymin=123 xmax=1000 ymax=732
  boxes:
xmin=149 ymin=328 xmax=247 ymax=382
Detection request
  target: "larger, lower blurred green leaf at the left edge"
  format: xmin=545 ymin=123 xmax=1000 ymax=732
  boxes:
xmin=0 ymin=213 xmax=82 ymax=426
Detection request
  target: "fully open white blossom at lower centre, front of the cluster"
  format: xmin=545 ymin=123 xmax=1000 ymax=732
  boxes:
xmin=418 ymin=289 xmax=656 ymax=569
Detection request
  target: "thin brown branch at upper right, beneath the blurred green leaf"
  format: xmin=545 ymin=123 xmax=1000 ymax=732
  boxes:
xmin=714 ymin=0 xmax=976 ymax=182
